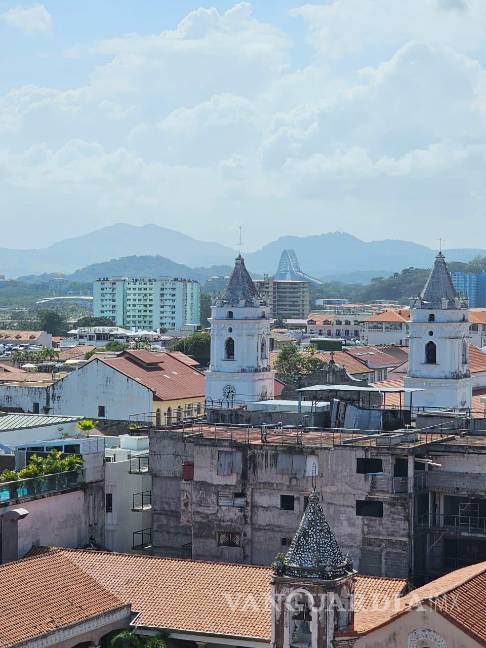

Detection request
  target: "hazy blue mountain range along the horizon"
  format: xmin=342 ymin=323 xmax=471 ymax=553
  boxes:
xmin=5 ymin=224 xmax=486 ymax=281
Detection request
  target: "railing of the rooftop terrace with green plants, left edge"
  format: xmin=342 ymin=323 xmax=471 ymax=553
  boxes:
xmin=0 ymin=470 xmax=84 ymax=504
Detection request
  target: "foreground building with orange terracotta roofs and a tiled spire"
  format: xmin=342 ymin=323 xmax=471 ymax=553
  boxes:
xmin=0 ymin=502 xmax=486 ymax=648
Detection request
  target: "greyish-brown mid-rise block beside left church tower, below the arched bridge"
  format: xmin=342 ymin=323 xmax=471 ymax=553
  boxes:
xmin=254 ymin=278 xmax=310 ymax=319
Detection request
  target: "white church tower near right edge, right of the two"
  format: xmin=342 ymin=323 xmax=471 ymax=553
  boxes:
xmin=405 ymin=252 xmax=472 ymax=409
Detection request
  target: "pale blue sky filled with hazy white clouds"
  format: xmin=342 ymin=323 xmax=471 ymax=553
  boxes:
xmin=0 ymin=0 xmax=486 ymax=251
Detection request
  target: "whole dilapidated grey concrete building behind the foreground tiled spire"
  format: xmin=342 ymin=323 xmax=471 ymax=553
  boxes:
xmin=150 ymin=424 xmax=486 ymax=580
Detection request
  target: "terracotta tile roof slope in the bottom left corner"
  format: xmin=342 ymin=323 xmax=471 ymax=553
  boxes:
xmin=0 ymin=552 xmax=128 ymax=647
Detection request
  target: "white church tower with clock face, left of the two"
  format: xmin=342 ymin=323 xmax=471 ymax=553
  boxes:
xmin=206 ymin=255 xmax=274 ymax=406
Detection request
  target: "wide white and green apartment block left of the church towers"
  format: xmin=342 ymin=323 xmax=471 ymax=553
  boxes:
xmin=93 ymin=277 xmax=201 ymax=331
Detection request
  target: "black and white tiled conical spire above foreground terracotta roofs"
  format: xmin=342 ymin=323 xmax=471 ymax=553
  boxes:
xmin=281 ymin=492 xmax=353 ymax=580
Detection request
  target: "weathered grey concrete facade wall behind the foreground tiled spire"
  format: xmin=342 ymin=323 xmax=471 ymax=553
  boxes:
xmin=150 ymin=433 xmax=411 ymax=577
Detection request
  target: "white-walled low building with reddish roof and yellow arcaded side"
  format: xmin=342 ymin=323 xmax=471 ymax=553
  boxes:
xmin=0 ymin=350 xmax=204 ymax=424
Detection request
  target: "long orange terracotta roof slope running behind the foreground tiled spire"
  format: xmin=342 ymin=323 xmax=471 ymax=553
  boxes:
xmin=35 ymin=549 xmax=407 ymax=641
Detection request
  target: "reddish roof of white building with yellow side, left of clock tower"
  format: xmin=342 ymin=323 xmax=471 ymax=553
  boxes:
xmin=97 ymin=351 xmax=204 ymax=401
